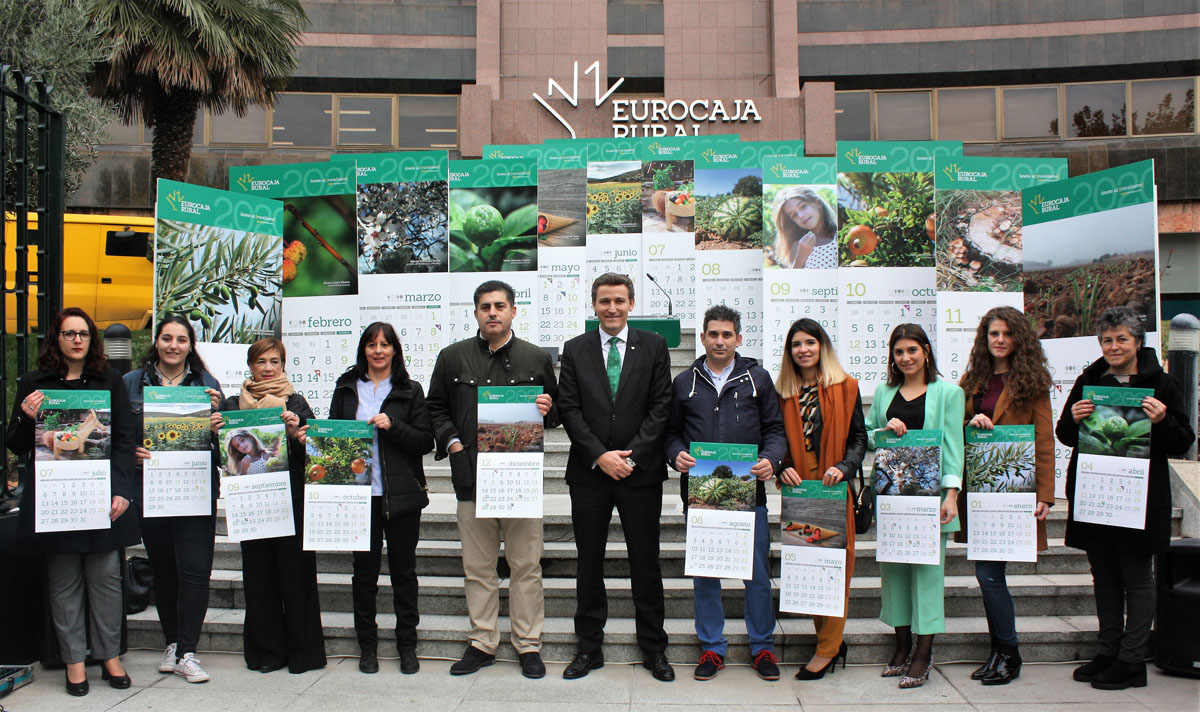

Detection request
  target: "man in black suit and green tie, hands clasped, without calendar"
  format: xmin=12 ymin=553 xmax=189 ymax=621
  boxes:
xmin=558 ymin=273 xmax=674 ymax=682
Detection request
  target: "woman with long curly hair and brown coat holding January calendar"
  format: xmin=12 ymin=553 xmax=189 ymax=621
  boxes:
xmin=954 ymin=306 xmax=1054 ymax=684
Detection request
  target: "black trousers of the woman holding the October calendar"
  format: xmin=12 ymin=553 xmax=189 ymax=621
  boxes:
xmin=350 ymin=497 xmax=421 ymax=651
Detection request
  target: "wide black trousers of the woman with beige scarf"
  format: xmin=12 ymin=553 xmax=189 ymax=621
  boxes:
xmin=241 ymin=528 xmax=325 ymax=674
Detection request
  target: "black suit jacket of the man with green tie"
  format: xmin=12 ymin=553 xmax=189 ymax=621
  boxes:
xmin=558 ymin=329 xmax=671 ymax=486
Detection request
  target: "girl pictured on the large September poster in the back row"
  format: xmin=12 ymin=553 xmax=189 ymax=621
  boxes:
xmin=770 ymin=185 xmax=838 ymax=269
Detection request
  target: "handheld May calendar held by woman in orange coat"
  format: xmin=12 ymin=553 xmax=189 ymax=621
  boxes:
xmin=779 ymin=480 xmax=850 ymax=617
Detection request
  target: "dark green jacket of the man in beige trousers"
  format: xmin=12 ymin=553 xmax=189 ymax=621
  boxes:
xmin=426 ymin=334 xmax=558 ymax=502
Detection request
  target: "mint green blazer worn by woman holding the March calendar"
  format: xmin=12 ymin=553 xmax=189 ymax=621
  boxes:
xmin=866 ymin=378 xmax=966 ymax=532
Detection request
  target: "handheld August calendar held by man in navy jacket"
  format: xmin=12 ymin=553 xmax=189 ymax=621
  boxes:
xmin=683 ymin=442 xmax=758 ymax=580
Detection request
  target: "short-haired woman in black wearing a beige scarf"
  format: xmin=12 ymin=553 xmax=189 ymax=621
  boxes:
xmin=212 ymin=337 xmax=325 ymax=674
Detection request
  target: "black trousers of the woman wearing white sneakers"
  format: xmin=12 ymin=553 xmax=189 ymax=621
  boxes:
xmin=142 ymin=514 xmax=217 ymax=658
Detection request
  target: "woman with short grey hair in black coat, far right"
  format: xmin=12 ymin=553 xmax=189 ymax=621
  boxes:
xmin=1055 ymin=306 xmax=1195 ymax=689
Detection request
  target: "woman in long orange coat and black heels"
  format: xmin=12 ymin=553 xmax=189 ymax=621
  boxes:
xmin=775 ymin=318 xmax=866 ymax=680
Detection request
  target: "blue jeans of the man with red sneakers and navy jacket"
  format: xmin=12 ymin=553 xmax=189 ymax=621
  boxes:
xmin=691 ymin=507 xmax=775 ymax=658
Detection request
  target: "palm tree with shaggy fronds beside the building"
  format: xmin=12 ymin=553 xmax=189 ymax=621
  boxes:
xmin=90 ymin=0 xmax=308 ymax=180
